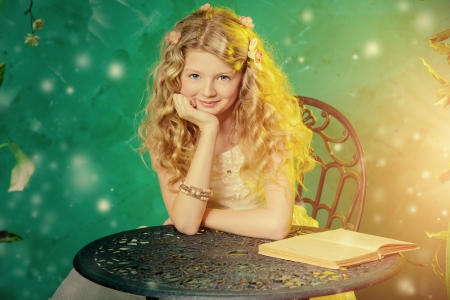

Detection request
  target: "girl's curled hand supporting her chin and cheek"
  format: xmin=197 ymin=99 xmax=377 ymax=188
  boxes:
xmin=173 ymin=94 xmax=219 ymax=131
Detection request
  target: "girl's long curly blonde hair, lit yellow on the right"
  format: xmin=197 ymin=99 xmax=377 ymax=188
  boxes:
xmin=138 ymin=8 xmax=314 ymax=191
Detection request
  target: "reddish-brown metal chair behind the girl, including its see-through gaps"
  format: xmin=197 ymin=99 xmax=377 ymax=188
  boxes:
xmin=295 ymin=96 xmax=366 ymax=231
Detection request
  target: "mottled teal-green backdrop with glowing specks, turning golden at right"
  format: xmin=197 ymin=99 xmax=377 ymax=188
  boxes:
xmin=0 ymin=0 xmax=450 ymax=299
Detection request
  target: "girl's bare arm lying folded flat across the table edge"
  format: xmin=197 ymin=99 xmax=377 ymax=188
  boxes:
xmin=201 ymin=151 xmax=295 ymax=240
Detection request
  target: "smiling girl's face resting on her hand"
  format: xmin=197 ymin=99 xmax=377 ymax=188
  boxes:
xmin=180 ymin=50 xmax=242 ymax=122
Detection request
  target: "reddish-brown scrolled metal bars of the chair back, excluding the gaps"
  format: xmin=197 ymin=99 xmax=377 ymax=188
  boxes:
xmin=295 ymin=96 xmax=366 ymax=231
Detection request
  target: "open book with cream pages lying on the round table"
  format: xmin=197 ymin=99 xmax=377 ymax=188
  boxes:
xmin=259 ymin=229 xmax=419 ymax=269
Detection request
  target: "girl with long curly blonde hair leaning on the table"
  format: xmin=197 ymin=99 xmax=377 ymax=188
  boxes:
xmin=53 ymin=4 xmax=352 ymax=299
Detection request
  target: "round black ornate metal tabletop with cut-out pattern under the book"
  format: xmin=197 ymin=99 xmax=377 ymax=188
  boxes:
xmin=73 ymin=226 xmax=402 ymax=299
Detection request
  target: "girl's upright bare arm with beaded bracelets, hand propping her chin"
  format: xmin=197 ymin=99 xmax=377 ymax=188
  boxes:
xmin=150 ymin=94 xmax=219 ymax=235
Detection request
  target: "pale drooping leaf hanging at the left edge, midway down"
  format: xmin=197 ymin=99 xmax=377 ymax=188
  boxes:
xmin=8 ymin=140 xmax=35 ymax=192
